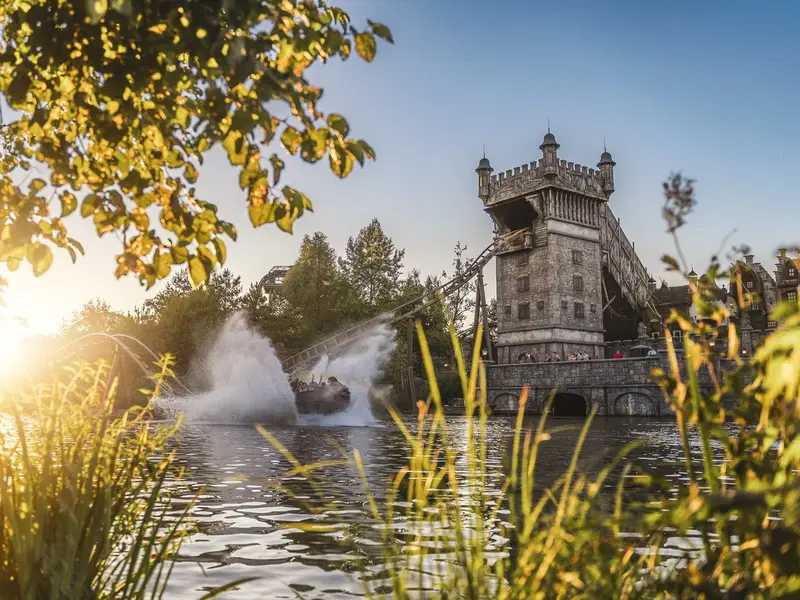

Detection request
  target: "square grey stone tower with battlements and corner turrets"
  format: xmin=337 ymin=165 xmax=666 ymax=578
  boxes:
xmin=476 ymin=131 xmax=615 ymax=363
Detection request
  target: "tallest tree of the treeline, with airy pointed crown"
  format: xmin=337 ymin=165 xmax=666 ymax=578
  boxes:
xmin=341 ymin=219 xmax=406 ymax=309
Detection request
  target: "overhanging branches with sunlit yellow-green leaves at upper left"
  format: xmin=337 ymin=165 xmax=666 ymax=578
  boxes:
xmin=0 ymin=0 xmax=392 ymax=288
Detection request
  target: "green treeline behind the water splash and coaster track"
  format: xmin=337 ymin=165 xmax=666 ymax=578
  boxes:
xmin=20 ymin=219 xmax=496 ymax=412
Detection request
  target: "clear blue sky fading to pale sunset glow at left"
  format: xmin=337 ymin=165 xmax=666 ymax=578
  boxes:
xmin=0 ymin=0 xmax=800 ymax=354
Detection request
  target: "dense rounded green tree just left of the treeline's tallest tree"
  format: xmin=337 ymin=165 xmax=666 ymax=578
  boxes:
xmin=284 ymin=231 xmax=352 ymax=343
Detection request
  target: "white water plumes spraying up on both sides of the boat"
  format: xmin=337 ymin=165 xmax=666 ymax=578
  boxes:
xmin=154 ymin=313 xmax=395 ymax=426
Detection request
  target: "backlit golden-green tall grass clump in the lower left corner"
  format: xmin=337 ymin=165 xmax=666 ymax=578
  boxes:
xmin=0 ymin=359 xmax=188 ymax=600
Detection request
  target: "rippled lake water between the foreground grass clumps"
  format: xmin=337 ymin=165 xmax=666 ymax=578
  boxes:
xmin=156 ymin=417 xmax=683 ymax=599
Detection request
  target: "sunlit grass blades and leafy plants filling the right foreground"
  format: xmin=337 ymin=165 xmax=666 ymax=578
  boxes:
xmin=262 ymin=278 xmax=800 ymax=600
